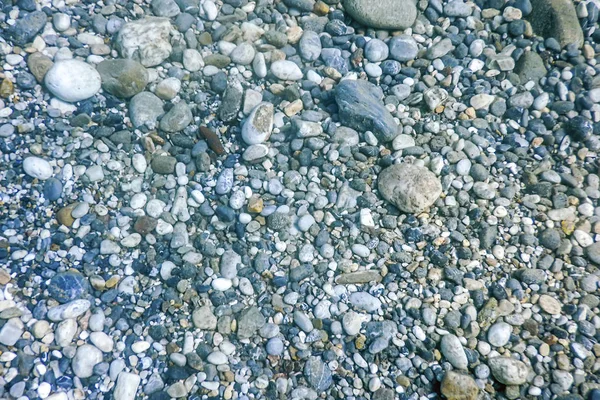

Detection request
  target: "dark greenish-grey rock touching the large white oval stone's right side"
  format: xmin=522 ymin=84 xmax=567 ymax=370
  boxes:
xmin=96 ymin=59 xmax=148 ymax=99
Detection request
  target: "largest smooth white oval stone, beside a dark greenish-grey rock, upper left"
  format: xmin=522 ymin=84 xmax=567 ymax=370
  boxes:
xmin=44 ymin=59 xmax=102 ymax=103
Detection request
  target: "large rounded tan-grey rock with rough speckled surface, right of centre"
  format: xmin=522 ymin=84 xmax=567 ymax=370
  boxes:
xmin=377 ymin=164 xmax=442 ymax=214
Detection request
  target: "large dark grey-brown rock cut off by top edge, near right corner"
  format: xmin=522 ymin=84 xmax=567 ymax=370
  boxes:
xmin=530 ymin=0 xmax=583 ymax=47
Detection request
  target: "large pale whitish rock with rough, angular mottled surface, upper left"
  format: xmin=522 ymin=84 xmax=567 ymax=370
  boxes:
xmin=115 ymin=17 xmax=173 ymax=67
